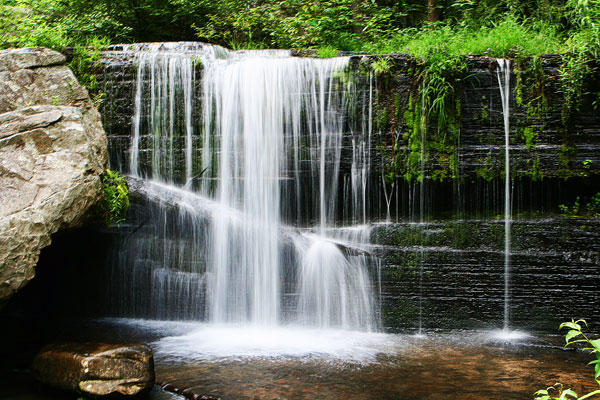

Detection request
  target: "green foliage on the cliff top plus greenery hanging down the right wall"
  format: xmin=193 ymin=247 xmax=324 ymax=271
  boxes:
xmin=0 ymin=0 xmax=600 ymax=189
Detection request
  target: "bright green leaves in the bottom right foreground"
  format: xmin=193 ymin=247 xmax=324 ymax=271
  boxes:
xmin=534 ymin=319 xmax=600 ymax=400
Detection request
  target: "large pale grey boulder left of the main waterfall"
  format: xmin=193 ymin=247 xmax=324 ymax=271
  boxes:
xmin=0 ymin=48 xmax=107 ymax=303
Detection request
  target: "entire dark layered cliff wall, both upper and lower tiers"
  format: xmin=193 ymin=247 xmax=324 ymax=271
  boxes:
xmin=90 ymin=48 xmax=600 ymax=331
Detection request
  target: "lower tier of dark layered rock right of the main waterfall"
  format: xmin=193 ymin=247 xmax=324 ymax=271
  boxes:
xmin=372 ymin=218 xmax=600 ymax=332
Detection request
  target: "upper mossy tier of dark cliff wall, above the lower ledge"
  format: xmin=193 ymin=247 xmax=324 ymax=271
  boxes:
xmin=98 ymin=46 xmax=600 ymax=219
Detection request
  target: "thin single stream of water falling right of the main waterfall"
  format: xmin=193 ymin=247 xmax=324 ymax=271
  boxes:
xmin=496 ymin=59 xmax=511 ymax=331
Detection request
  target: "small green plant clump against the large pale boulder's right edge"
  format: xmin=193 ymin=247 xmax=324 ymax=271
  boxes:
xmin=100 ymin=169 xmax=129 ymax=226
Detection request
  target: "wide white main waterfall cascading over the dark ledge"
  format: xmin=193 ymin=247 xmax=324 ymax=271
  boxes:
xmin=108 ymin=44 xmax=378 ymax=331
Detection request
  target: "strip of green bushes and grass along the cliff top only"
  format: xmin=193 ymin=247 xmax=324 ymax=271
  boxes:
xmin=0 ymin=0 xmax=600 ymax=58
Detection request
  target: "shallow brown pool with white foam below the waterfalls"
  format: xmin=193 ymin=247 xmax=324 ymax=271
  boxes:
xmin=0 ymin=319 xmax=598 ymax=400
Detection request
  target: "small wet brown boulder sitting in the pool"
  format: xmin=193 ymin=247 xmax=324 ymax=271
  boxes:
xmin=33 ymin=343 xmax=154 ymax=397
